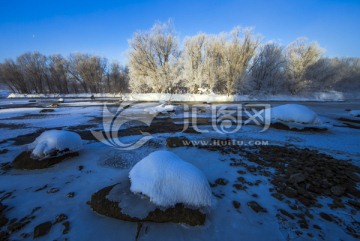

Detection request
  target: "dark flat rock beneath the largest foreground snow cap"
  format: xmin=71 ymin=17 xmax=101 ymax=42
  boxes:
xmin=89 ymin=186 xmax=206 ymax=226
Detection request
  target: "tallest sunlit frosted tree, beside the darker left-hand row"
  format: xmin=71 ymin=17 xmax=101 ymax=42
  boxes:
xmin=129 ymin=21 xmax=180 ymax=93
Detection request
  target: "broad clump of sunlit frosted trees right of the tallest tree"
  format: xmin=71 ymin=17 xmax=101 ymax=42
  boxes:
xmin=182 ymin=27 xmax=260 ymax=95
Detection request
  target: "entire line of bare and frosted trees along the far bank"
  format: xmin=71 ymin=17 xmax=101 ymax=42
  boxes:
xmin=0 ymin=22 xmax=360 ymax=95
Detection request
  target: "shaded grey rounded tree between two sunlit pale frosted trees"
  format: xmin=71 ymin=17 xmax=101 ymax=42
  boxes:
xmin=247 ymin=43 xmax=286 ymax=94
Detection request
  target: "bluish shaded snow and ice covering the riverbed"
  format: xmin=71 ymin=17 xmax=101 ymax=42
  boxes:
xmin=0 ymin=99 xmax=360 ymax=241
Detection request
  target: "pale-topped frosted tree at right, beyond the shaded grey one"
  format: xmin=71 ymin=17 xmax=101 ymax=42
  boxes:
xmin=286 ymin=38 xmax=323 ymax=94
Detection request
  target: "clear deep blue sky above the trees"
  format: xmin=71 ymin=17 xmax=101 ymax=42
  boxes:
xmin=0 ymin=0 xmax=360 ymax=63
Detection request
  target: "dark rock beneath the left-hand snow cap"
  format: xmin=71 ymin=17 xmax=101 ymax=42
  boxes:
xmin=12 ymin=151 xmax=79 ymax=170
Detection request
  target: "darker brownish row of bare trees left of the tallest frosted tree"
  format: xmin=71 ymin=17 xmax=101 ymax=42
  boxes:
xmin=0 ymin=52 xmax=129 ymax=94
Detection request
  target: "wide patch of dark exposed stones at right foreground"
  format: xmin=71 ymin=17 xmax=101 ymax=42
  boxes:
xmin=238 ymin=146 xmax=360 ymax=208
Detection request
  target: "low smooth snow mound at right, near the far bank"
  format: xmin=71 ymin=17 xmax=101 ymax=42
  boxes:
xmin=271 ymin=104 xmax=321 ymax=124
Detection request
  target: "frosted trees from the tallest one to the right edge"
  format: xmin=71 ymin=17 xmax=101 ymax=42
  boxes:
xmin=129 ymin=22 xmax=360 ymax=95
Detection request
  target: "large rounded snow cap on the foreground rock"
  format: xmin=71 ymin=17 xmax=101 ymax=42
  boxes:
xmin=129 ymin=151 xmax=212 ymax=207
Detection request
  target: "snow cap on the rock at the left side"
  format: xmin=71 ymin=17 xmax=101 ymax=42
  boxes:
xmin=28 ymin=130 xmax=82 ymax=158
